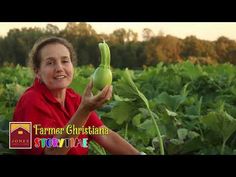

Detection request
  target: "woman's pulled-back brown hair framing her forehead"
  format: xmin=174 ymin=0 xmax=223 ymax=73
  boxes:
xmin=28 ymin=36 xmax=77 ymax=71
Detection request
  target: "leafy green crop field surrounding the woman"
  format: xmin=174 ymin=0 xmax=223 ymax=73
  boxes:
xmin=0 ymin=62 xmax=236 ymax=155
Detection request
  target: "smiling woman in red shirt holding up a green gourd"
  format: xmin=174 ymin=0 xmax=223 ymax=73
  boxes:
xmin=13 ymin=37 xmax=139 ymax=155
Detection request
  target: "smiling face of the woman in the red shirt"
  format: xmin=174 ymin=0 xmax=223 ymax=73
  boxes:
xmin=37 ymin=43 xmax=74 ymax=90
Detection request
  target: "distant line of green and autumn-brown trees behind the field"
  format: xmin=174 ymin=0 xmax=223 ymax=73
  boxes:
xmin=0 ymin=22 xmax=236 ymax=69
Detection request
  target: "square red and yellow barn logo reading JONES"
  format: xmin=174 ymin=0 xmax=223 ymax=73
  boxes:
xmin=9 ymin=122 xmax=32 ymax=149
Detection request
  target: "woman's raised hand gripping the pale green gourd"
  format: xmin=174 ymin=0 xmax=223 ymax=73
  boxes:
xmin=80 ymin=80 xmax=112 ymax=113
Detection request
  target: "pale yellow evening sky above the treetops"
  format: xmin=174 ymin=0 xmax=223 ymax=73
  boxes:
xmin=0 ymin=22 xmax=236 ymax=41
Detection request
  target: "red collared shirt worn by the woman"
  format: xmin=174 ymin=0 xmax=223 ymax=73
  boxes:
xmin=13 ymin=79 xmax=103 ymax=155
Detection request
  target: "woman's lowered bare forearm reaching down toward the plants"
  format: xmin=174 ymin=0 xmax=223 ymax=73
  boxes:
xmin=94 ymin=125 xmax=140 ymax=155
